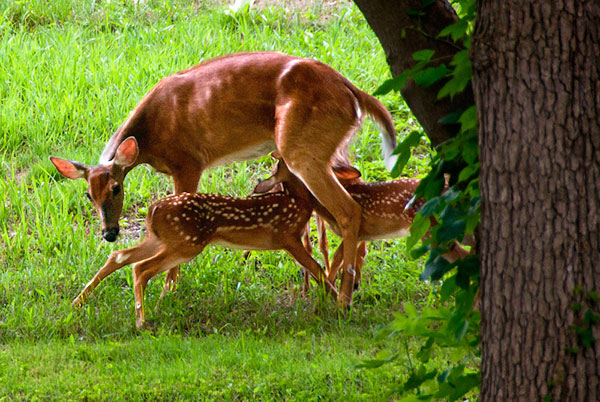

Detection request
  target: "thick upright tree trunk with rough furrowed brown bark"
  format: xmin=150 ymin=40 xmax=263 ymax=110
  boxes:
xmin=471 ymin=0 xmax=600 ymax=401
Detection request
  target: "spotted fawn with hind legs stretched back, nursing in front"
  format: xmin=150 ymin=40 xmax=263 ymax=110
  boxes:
xmin=73 ymin=155 xmax=337 ymax=328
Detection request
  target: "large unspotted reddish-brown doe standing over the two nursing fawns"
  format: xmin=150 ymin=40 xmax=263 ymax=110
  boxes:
xmin=51 ymin=53 xmax=396 ymax=304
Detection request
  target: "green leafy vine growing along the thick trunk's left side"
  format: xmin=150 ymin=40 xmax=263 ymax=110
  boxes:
xmin=363 ymin=0 xmax=480 ymax=400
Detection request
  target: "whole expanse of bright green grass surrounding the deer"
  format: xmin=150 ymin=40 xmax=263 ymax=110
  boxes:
xmin=0 ymin=0 xmax=434 ymax=400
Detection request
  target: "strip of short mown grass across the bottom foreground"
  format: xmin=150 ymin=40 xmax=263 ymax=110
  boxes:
xmin=0 ymin=331 xmax=418 ymax=401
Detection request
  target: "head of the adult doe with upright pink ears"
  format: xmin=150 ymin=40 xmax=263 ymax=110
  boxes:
xmin=50 ymin=137 xmax=139 ymax=242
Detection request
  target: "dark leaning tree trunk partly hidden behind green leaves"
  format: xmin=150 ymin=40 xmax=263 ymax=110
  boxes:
xmin=355 ymin=0 xmax=474 ymax=146
